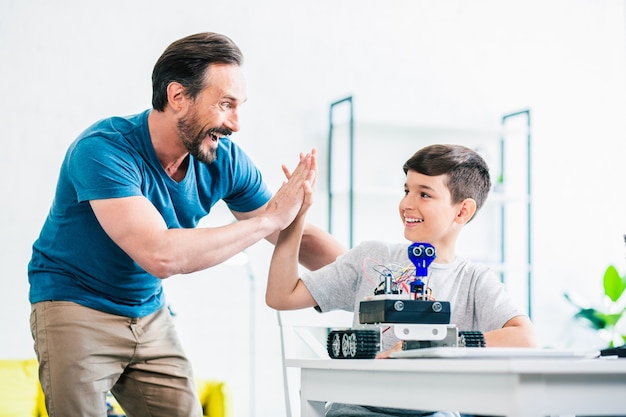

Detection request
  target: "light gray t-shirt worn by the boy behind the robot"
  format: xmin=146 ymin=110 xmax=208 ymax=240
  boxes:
xmin=301 ymin=241 xmax=525 ymax=416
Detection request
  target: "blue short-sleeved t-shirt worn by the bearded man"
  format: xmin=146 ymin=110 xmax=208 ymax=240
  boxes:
xmin=28 ymin=110 xmax=271 ymax=317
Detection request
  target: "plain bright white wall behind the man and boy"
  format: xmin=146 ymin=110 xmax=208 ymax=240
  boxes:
xmin=0 ymin=0 xmax=626 ymax=416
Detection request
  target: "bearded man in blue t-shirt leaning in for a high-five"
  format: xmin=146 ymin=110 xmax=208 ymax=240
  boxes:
xmin=29 ymin=33 xmax=343 ymax=417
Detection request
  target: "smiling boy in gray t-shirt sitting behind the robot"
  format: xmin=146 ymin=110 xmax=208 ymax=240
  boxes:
xmin=266 ymin=145 xmax=538 ymax=417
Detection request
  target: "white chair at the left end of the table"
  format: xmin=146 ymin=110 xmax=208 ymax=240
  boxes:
xmin=277 ymin=308 xmax=353 ymax=417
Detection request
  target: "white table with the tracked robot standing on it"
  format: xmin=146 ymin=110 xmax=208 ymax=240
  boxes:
xmin=286 ymin=357 xmax=626 ymax=417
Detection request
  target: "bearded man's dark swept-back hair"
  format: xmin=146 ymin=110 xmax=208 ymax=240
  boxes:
xmin=152 ymin=32 xmax=243 ymax=111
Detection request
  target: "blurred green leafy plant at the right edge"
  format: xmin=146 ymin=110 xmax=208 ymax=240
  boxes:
xmin=564 ymin=265 xmax=626 ymax=347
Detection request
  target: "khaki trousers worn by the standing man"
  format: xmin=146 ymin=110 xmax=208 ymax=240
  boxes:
xmin=30 ymin=301 xmax=202 ymax=417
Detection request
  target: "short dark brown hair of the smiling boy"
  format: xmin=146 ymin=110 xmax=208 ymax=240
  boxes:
xmin=403 ymin=145 xmax=491 ymax=211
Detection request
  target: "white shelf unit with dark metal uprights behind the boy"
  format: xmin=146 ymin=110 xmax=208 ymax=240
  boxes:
xmin=327 ymin=97 xmax=532 ymax=314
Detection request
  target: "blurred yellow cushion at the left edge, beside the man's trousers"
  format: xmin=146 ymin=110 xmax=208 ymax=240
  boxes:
xmin=0 ymin=359 xmax=47 ymax=417
